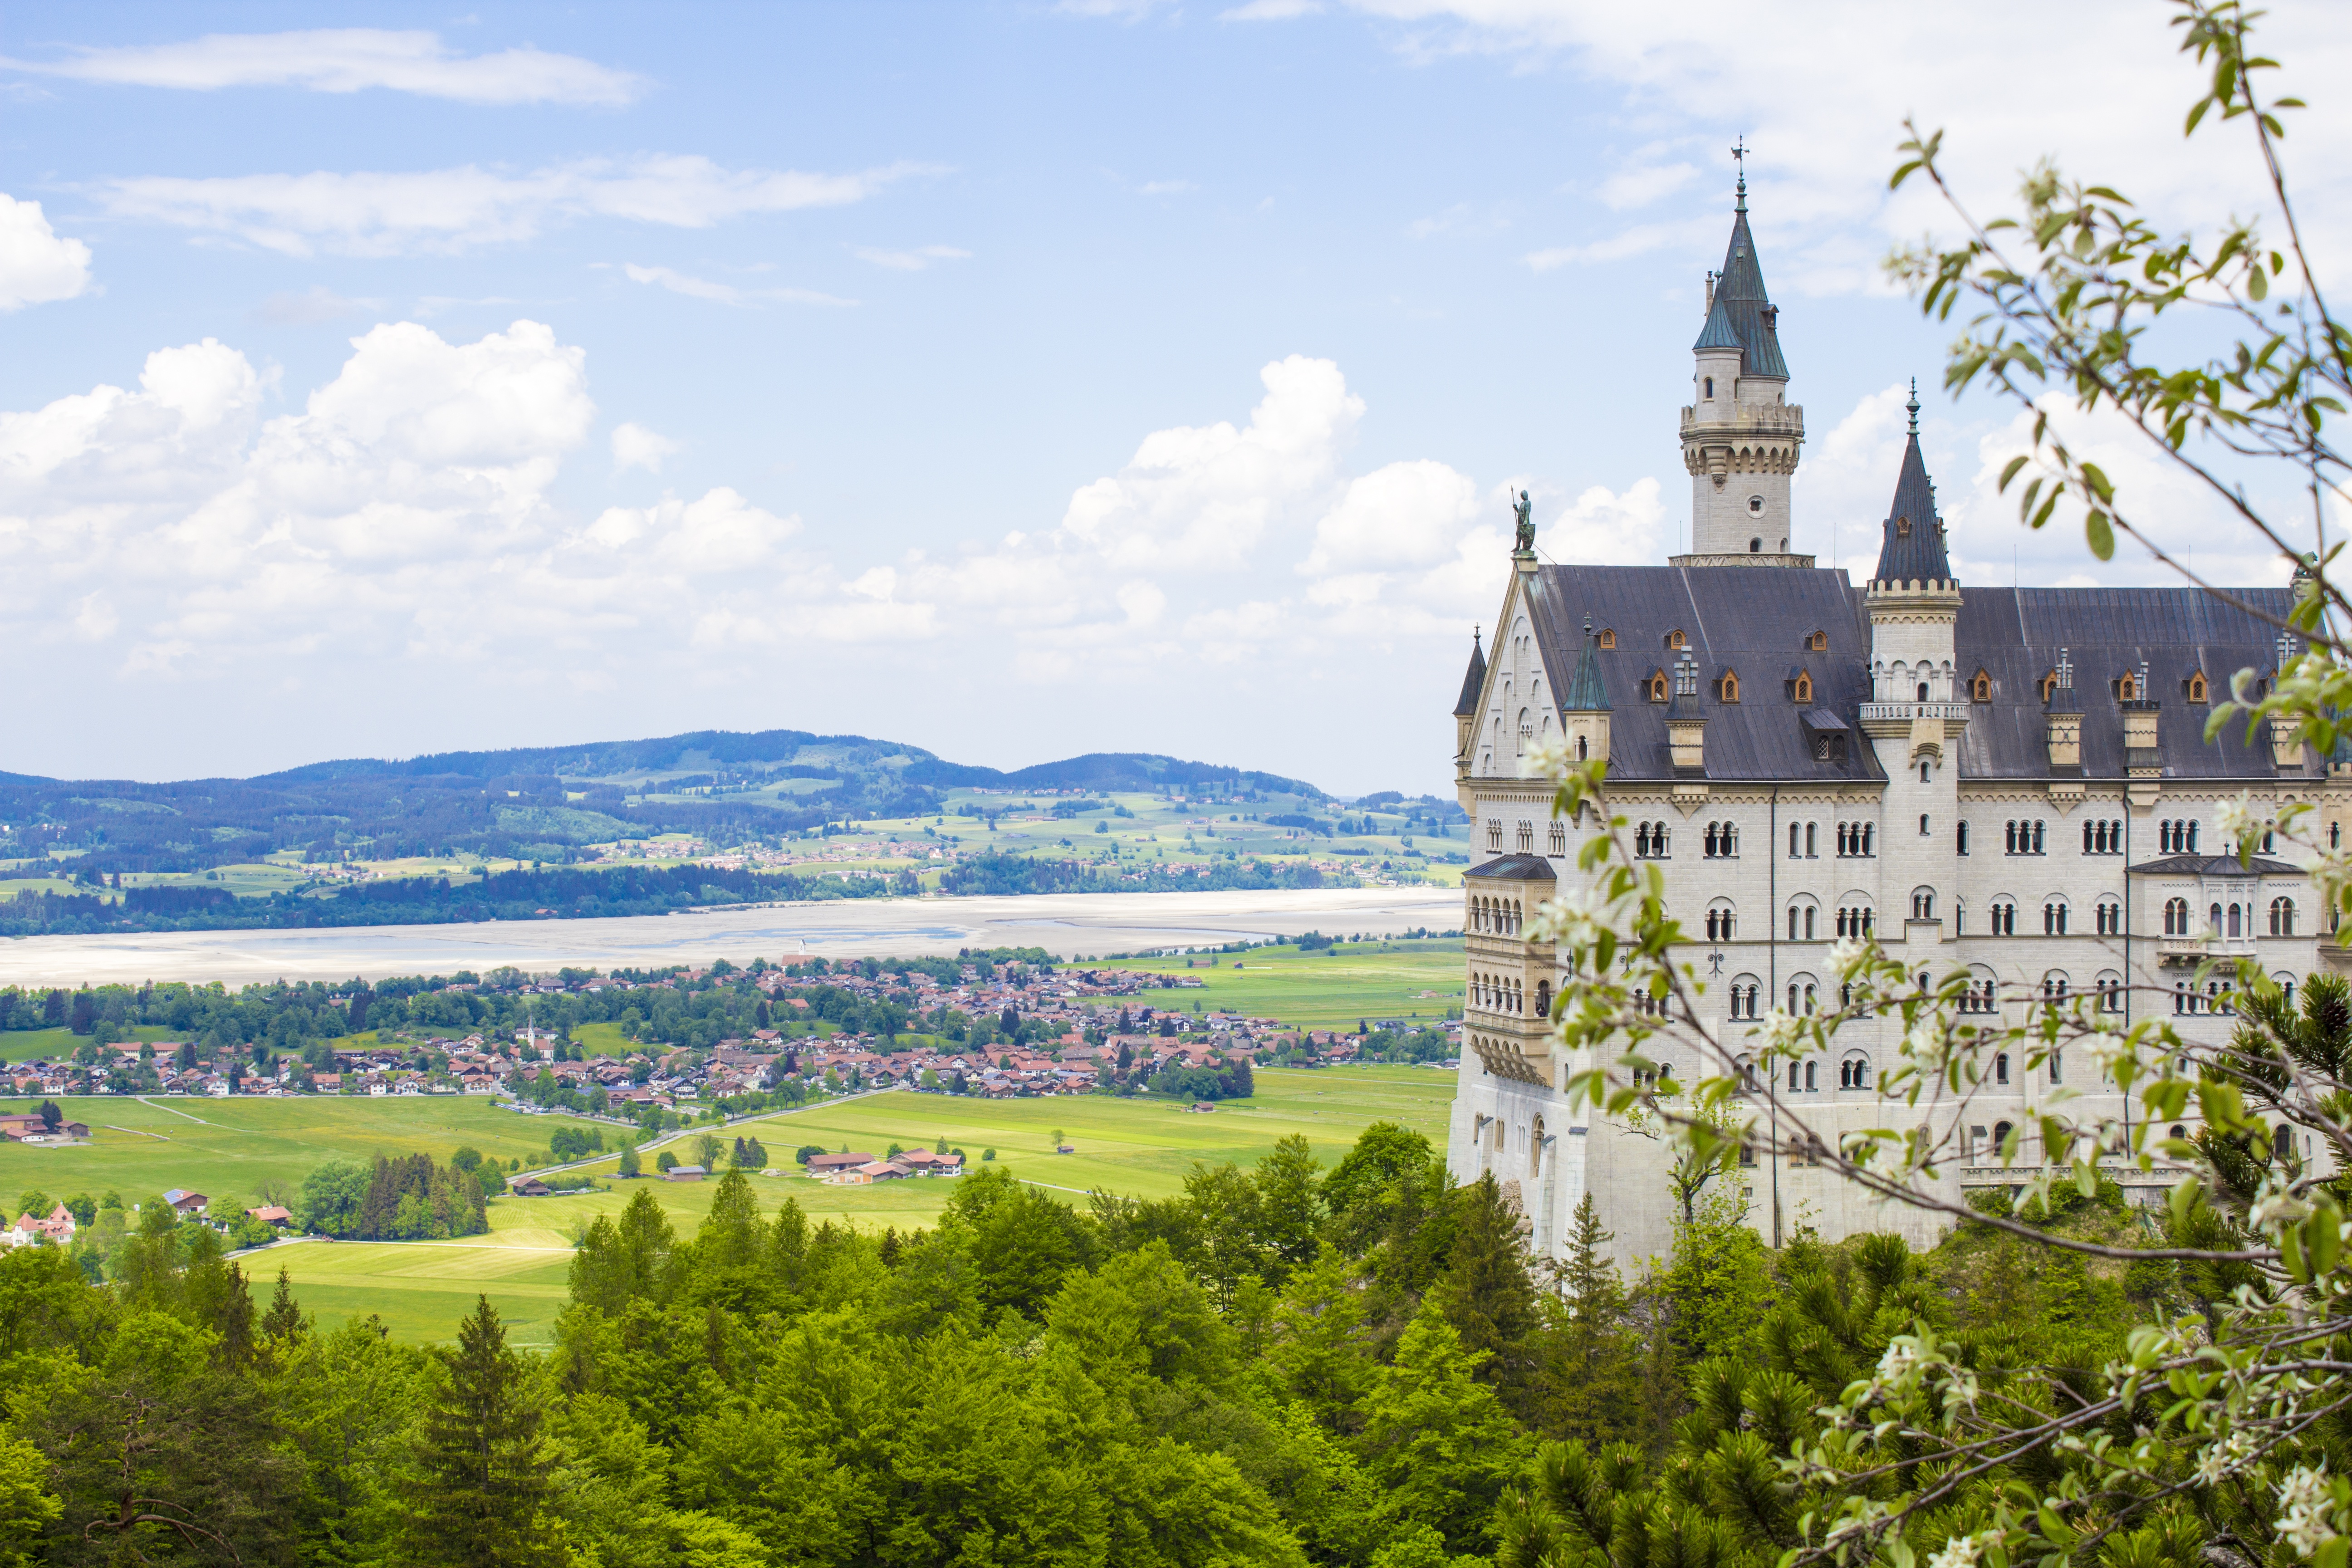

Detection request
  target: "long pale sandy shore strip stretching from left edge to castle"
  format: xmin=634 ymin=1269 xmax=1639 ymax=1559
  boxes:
xmin=0 ymin=889 xmax=1460 ymax=985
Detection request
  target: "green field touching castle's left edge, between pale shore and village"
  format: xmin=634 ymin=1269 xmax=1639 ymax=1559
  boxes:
xmin=1096 ymin=938 xmax=1463 ymax=1029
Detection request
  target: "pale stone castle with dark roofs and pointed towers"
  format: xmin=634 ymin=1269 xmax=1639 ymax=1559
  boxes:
xmin=1446 ymin=166 xmax=2323 ymax=1260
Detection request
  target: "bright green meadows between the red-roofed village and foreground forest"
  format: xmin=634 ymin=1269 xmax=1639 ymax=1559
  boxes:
xmin=0 ymin=1067 xmax=1454 ymax=1345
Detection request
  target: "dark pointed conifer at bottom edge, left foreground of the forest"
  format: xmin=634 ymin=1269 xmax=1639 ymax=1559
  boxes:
xmin=405 ymin=1295 xmax=564 ymax=1568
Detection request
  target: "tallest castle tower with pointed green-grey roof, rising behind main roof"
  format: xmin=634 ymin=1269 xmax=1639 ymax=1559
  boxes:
xmin=1677 ymin=148 xmax=1813 ymax=567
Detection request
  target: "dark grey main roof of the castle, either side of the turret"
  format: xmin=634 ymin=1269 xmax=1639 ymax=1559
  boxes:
xmin=1526 ymin=567 xmax=2293 ymax=783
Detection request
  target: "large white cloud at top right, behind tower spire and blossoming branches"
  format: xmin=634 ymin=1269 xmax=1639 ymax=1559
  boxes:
xmin=1308 ymin=0 xmax=2352 ymax=294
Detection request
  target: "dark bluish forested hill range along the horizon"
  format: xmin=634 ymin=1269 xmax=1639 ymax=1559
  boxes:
xmin=0 ymin=729 xmax=1322 ymax=884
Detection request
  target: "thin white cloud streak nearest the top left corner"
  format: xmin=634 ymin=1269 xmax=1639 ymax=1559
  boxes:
xmin=0 ymin=28 xmax=644 ymax=106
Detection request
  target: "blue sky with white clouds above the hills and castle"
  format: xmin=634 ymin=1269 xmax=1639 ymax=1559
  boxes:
xmin=0 ymin=0 xmax=2352 ymax=794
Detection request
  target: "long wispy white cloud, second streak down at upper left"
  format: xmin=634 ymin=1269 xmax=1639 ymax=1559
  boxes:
xmin=97 ymin=155 xmax=929 ymax=256
